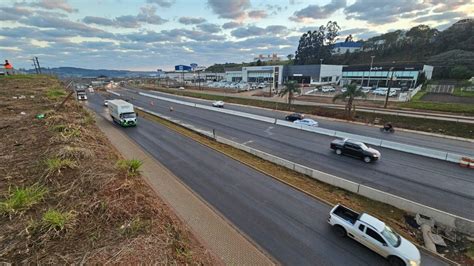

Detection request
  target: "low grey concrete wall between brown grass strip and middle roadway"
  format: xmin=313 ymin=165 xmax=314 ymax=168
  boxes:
xmin=137 ymin=107 xmax=474 ymax=236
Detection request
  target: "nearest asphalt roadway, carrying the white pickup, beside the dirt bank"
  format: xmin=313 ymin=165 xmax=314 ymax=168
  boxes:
xmin=88 ymin=95 xmax=444 ymax=265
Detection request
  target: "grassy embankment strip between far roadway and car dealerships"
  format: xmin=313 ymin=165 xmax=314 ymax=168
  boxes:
xmin=140 ymin=87 xmax=474 ymax=138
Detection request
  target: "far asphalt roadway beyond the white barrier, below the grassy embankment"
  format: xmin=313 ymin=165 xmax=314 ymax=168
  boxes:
xmin=123 ymin=88 xmax=474 ymax=156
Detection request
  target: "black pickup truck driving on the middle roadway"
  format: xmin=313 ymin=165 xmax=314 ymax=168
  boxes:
xmin=331 ymin=139 xmax=380 ymax=163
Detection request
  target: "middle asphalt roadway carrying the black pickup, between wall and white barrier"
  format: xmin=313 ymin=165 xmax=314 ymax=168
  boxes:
xmin=108 ymin=88 xmax=474 ymax=219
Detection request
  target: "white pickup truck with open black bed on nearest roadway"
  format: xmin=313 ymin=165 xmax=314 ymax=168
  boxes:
xmin=328 ymin=204 xmax=421 ymax=266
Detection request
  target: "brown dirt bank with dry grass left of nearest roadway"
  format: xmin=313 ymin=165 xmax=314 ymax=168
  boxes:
xmin=0 ymin=76 xmax=215 ymax=265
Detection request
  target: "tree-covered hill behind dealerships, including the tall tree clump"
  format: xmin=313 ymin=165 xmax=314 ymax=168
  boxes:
xmin=206 ymin=19 xmax=474 ymax=79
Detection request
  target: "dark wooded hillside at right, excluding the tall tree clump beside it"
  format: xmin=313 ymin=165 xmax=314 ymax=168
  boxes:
xmin=327 ymin=19 xmax=474 ymax=78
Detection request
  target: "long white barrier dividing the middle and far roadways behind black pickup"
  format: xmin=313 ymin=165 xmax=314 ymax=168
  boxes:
xmin=138 ymin=92 xmax=474 ymax=163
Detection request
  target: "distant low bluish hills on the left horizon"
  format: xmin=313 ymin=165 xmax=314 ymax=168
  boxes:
xmin=26 ymin=67 xmax=157 ymax=78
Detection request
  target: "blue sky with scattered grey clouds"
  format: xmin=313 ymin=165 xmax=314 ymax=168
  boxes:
xmin=0 ymin=0 xmax=474 ymax=70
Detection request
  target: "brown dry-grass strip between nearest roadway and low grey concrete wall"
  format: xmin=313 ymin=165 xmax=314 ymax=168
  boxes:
xmin=139 ymin=111 xmax=474 ymax=265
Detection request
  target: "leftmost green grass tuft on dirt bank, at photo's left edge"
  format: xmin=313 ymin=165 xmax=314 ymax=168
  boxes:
xmin=0 ymin=184 xmax=48 ymax=214
